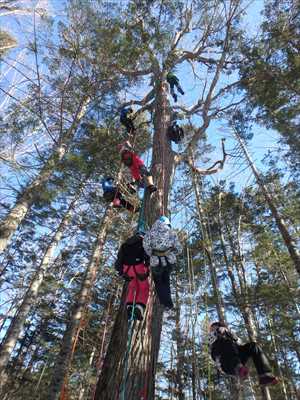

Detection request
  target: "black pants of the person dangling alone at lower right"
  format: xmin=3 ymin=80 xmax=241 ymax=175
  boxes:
xmin=213 ymin=339 xmax=271 ymax=375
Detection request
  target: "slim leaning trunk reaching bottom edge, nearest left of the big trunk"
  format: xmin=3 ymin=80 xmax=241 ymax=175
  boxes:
xmin=48 ymin=208 xmax=112 ymax=400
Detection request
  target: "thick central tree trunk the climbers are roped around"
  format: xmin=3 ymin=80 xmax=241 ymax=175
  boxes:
xmin=95 ymin=76 xmax=175 ymax=400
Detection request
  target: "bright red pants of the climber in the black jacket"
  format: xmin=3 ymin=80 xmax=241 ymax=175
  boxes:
xmin=123 ymin=264 xmax=149 ymax=306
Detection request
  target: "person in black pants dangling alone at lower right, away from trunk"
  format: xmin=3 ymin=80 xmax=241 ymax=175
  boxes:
xmin=209 ymin=321 xmax=278 ymax=385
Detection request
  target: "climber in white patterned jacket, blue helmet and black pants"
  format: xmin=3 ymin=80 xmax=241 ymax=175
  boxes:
xmin=143 ymin=216 xmax=182 ymax=308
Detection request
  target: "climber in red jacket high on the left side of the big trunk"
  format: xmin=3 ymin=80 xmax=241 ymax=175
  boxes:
xmin=119 ymin=144 xmax=157 ymax=193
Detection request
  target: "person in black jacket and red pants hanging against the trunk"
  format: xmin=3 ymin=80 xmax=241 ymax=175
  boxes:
xmin=115 ymin=232 xmax=149 ymax=320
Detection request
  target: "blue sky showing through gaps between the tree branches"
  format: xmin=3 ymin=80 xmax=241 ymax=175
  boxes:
xmin=0 ymin=0 xmax=288 ymax=219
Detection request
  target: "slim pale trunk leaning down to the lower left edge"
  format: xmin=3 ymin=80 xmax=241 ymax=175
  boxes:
xmin=0 ymin=197 xmax=77 ymax=389
